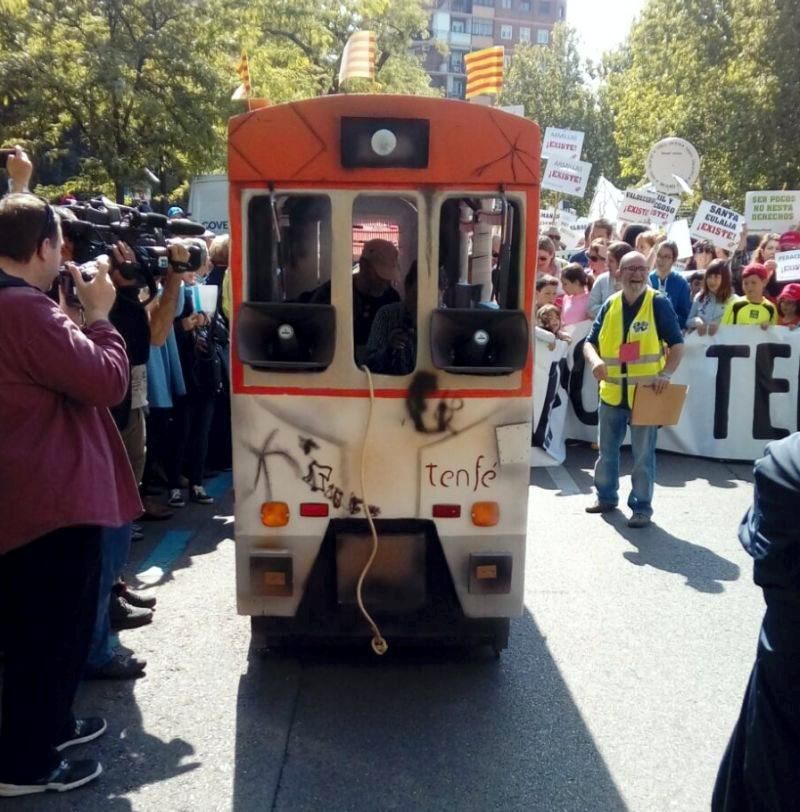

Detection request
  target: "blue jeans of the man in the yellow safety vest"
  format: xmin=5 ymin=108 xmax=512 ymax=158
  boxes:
xmin=594 ymin=401 xmax=658 ymax=516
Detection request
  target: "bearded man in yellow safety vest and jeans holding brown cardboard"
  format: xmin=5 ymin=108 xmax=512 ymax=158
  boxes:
xmin=583 ymin=251 xmax=683 ymax=528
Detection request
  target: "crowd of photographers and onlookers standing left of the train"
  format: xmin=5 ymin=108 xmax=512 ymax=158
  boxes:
xmin=0 ymin=148 xmax=231 ymax=797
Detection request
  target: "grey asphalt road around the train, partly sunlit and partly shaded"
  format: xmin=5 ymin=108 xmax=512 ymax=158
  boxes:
xmin=2 ymin=446 xmax=761 ymax=812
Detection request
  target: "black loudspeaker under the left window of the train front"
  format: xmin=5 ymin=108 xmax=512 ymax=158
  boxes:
xmin=236 ymin=302 xmax=336 ymax=372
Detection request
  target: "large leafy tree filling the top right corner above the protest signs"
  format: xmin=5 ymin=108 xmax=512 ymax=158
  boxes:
xmin=601 ymin=0 xmax=800 ymax=210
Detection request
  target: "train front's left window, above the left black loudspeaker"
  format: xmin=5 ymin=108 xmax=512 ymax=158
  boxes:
xmin=247 ymin=195 xmax=331 ymax=304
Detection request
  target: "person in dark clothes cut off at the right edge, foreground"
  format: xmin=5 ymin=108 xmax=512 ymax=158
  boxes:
xmin=711 ymin=432 xmax=800 ymax=812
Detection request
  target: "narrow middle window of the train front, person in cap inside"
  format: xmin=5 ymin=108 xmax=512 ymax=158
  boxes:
xmin=352 ymin=195 xmax=418 ymax=375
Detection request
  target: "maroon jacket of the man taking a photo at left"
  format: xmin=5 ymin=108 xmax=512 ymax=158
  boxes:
xmin=0 ymin=286 xmax=142 ymax=554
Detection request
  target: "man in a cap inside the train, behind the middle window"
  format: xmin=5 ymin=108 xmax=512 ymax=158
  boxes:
xmin=311 ymin=239 xmax=400 ymax=365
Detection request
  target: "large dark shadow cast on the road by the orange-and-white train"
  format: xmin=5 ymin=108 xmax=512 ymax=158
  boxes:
xmin=233 ymin=611 xmax=625 ymax=812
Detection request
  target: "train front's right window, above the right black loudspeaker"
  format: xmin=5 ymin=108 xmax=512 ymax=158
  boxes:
xmin=439 ymin=197 xmax=522 ymax=310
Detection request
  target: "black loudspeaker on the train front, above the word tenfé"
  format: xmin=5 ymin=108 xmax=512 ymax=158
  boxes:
xmin=431 ymin=308 xmax=530 ymax=375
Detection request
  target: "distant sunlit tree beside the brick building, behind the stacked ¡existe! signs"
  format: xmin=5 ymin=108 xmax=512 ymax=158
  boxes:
xmin=500 ymin=24 xmax=618 ymax=210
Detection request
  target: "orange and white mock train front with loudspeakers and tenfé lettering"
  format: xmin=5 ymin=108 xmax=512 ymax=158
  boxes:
xmin=229 ymin=96 xmax=539 ymax=650
